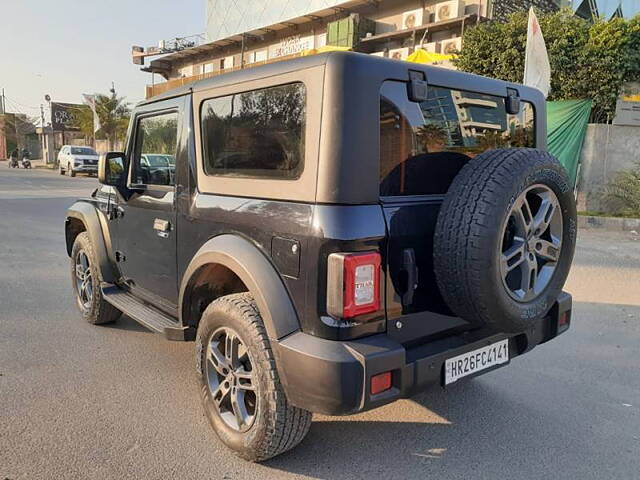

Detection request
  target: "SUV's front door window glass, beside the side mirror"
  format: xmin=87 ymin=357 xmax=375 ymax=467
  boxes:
xmin=131 ymin=112 xmax=178 ymax=186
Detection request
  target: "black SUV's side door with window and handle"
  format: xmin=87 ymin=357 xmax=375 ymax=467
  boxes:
xmin=116 ymin=98 xmax=184 ymax=311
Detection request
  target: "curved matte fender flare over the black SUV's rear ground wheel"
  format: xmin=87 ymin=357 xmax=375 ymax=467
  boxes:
xmin=179 ymin=234 xmax=300 ymax=341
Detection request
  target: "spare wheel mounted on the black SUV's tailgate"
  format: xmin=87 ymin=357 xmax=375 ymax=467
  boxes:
xmin=434 ymin=148 xmax=577 ymax=332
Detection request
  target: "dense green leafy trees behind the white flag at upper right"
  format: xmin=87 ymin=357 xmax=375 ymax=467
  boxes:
xmin=456 ymin=10 xmax=640 ymax=117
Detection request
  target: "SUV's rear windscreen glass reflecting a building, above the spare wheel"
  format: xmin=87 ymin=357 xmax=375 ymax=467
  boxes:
xmin=380 ymin=81 xmax=535 ymax=197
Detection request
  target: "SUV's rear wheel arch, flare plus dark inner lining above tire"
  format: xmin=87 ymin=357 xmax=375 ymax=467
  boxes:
xmin=178 ymin=234 xmax=300 ymax=341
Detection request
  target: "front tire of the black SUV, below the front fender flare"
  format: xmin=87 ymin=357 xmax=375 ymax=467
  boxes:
xmin=71 ymin=232 xmax=122 ymax=325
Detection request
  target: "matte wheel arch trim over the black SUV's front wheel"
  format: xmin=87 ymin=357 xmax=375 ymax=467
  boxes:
xmin=64 ymin=202 xmax=117 ymax=283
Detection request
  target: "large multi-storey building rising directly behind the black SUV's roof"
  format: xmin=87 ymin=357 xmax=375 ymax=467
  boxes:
xmin=139 ymin=0 xmax=558 ymax=97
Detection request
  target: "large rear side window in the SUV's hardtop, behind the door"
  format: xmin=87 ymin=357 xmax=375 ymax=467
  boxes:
xmin=201 ymin=83 xmax=306 ymax=180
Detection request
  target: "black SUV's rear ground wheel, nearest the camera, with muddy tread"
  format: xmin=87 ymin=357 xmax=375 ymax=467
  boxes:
xmin=196 ymin=292 xmax=311 ymax=462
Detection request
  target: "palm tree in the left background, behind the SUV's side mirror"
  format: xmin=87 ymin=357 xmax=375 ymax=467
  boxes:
xmin=75 ymin=90 xmax=131 ymax=148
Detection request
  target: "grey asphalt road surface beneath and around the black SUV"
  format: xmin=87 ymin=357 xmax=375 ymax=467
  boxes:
xmin=0 ymin=164 xmax=640 ymax=480
